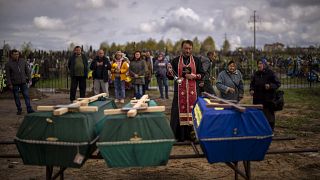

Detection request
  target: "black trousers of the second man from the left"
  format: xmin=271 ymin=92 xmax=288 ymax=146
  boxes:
xmin=70 ymin=76 xmax=87 ymax=101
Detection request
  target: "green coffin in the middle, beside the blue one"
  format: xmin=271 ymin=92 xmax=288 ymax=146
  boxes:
xmin=96 ymin=101 xmax=175 ymax=167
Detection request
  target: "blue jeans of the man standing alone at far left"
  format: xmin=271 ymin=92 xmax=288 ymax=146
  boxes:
xmin=13 ymin=83 xmax=33 ymax=112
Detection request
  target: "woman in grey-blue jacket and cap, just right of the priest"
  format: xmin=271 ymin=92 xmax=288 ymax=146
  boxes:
xmin=216 ymin=61 xmax=244 ymax=102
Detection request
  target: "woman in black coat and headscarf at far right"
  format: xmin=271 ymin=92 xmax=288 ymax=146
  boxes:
xmin=250 ymin=59 xmax=281 ymax=131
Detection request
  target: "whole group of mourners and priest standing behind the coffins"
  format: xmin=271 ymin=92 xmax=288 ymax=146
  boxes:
xmin=6 ymin=40 xmax=281 ymax=141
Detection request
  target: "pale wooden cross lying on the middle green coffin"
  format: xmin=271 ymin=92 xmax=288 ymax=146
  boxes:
xmin=104 ymin=95 xmax=165 ymax=117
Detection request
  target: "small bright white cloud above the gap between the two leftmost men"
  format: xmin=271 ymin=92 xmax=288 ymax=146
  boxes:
xmin=33 ymin=16 xmax=65 ymax=30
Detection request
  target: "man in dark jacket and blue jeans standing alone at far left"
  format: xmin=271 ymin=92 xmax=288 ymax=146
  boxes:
xmin=5 ymin=49 xmax=34 ymax=115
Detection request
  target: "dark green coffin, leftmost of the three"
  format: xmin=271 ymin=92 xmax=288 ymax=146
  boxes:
xmin=15 ymin=99 xmax=116 ymax=168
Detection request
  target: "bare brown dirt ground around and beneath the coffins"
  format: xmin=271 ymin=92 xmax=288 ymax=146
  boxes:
xmin=0 ymin=91 xmax=320 ymax=180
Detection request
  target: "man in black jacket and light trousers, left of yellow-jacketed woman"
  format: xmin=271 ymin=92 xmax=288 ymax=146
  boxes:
xmin=90 ymin=49 xmax=111 ymax=97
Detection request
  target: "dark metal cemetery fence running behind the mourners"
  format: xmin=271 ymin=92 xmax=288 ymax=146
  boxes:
xmin=0 ymin=54 xmax=320 ymax=93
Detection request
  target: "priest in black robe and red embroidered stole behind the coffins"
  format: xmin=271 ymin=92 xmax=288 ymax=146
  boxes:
xmin=167 ymin=40 xmax=205 ymax=141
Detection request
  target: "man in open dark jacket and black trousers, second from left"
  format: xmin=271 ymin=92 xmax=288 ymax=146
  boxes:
xmin=68 ymin=46 xmax=88 ymax=102
